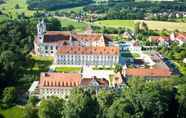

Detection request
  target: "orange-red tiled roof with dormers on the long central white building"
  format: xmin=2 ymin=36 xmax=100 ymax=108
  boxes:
xmin=58 ymin=46 xmax=119 ymax=55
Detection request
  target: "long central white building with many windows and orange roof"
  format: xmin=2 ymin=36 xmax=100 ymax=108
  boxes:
xmin=54 ymin=46 xmax=119 ymax=66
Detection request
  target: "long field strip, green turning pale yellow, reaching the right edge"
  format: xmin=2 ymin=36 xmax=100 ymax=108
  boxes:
xmin=95 ymin=20 xmax=186 ymax=32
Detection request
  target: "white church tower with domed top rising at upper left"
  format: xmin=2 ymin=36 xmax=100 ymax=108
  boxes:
xmin=37 ymin=19 xmax=46 ymax=43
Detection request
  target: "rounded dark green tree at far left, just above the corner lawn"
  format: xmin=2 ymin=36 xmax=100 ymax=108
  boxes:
xmin=2 ymin=87 xmax=16 ymax=106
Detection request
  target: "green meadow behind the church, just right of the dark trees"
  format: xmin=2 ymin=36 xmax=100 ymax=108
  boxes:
xmin=56 ymin=17 xmax=88 ymax=32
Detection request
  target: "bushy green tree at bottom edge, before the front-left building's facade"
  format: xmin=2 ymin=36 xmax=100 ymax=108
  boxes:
xmin=39 ymin=97 xmax=64 ymax=118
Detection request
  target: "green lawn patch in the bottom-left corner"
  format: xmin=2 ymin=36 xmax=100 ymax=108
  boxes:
xmin=0 ymin=106 xmax=24 ymax=118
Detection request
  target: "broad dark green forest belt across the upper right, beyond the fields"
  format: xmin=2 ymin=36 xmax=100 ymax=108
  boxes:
xmin=84 ymin=2 xmax=186 ymax=20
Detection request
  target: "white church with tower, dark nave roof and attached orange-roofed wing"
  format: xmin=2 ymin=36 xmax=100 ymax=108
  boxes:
xmin=34 ymin=20 xmax=112 ymax=56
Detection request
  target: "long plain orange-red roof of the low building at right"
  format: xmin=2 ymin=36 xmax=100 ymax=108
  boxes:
xmin=127 ymin=68 xmax=171 ymax=77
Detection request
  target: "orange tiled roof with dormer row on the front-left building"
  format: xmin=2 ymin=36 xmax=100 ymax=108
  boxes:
xmin=39 ymin=72 xmax=81 ymax=87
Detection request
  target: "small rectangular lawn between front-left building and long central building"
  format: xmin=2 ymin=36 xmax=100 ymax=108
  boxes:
xmin=55 ymin=67 xmax=81 ymax=73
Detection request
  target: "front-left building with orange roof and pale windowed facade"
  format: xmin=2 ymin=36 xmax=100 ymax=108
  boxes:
xmin=39 ymin=73 xmax=81 ymax=98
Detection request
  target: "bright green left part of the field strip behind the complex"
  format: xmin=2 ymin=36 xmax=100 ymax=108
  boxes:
xmin=95 ymin=20 xmax=135 ymax=29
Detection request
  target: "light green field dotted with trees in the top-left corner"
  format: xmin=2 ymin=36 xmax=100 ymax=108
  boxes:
xmin=0 ymin=0 xmax=34 ymax=17
